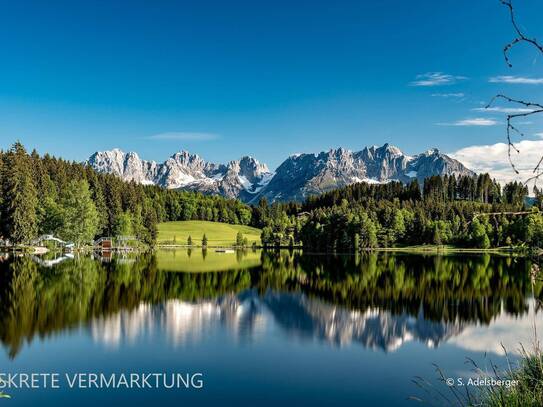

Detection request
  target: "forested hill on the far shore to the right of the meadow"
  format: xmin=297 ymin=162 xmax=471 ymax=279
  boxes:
xmin=262 ymin=174 xmax=543 ymax=252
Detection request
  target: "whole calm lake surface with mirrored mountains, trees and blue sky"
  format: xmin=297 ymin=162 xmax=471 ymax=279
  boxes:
xmin=0 ymin=250 xmax=543 ymax=406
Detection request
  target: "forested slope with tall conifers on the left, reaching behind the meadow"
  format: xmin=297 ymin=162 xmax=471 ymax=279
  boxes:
xmin=0 ymin=143 xmax=252 ymax=245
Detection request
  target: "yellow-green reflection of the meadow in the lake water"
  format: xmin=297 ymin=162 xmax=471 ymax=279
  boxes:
xmin=156 ymin=248 xmax=260 ymax=273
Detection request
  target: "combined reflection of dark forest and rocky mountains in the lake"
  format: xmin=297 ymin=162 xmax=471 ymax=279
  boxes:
xmin=0 ymin=251 xmax=542 ymax=357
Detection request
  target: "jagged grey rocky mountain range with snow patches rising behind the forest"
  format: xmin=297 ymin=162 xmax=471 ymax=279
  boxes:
xmin=86 ymin=144 xmax=474 ymax=203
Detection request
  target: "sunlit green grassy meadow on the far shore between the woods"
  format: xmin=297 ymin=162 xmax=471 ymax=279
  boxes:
xmin=158 ymin=220 xmax=261 ymax=247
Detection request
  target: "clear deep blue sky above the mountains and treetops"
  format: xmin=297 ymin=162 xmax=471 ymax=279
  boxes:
xmin=0 ymin=0 xmax=543 ymax=168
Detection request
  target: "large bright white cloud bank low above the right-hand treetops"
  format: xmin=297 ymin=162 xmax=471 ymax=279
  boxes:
xmin=449 ymin=136 xmax=543 ymax=184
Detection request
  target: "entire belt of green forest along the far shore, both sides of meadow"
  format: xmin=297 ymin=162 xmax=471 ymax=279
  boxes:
xmin=0 ymin=143 xmax=543 ymax=252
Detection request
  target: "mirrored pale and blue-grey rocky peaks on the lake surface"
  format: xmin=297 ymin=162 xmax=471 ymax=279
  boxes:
xmin=90 ymin=290 xmax=462 ymax=351
